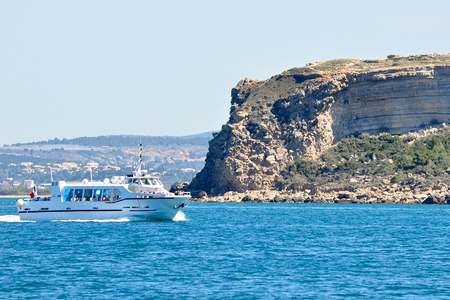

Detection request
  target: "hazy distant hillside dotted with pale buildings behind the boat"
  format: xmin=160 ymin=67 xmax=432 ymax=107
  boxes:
xmin=0 ymin=132 xmax=212 ymax=188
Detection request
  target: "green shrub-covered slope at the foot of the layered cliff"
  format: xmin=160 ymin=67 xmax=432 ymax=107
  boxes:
xmin=279 ymin=130 xmax=450 ymax=189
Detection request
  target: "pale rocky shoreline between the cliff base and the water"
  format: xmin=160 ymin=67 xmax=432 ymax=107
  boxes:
xmin=193 ymin=176 xmax=450 ymax=204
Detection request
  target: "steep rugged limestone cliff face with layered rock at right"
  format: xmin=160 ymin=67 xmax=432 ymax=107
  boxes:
xmin=190 ymin=55 xmax=450 ymax=194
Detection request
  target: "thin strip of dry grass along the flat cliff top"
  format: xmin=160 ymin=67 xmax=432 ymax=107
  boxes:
xmin=294 ymin=54 xmax=450 ymax=72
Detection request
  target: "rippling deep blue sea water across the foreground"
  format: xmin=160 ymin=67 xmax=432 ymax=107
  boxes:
xmin=0 ymin=199 xmax=450 ymax=299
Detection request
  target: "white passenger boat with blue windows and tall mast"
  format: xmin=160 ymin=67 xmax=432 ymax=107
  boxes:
xmin=17 ymin=146 xmax=191 ymax=221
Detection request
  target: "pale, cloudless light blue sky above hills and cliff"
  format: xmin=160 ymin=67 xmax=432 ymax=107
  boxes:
xmin=0 ymin=0 xmax=450 ymax=144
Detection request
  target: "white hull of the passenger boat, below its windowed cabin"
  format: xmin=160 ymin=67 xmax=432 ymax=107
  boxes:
xmin=18 ymin=196 xmax=189 ymax=221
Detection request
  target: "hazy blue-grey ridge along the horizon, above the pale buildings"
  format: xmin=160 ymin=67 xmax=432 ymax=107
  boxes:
xmin=11 ymin=132 xmax=212 ymax=147
